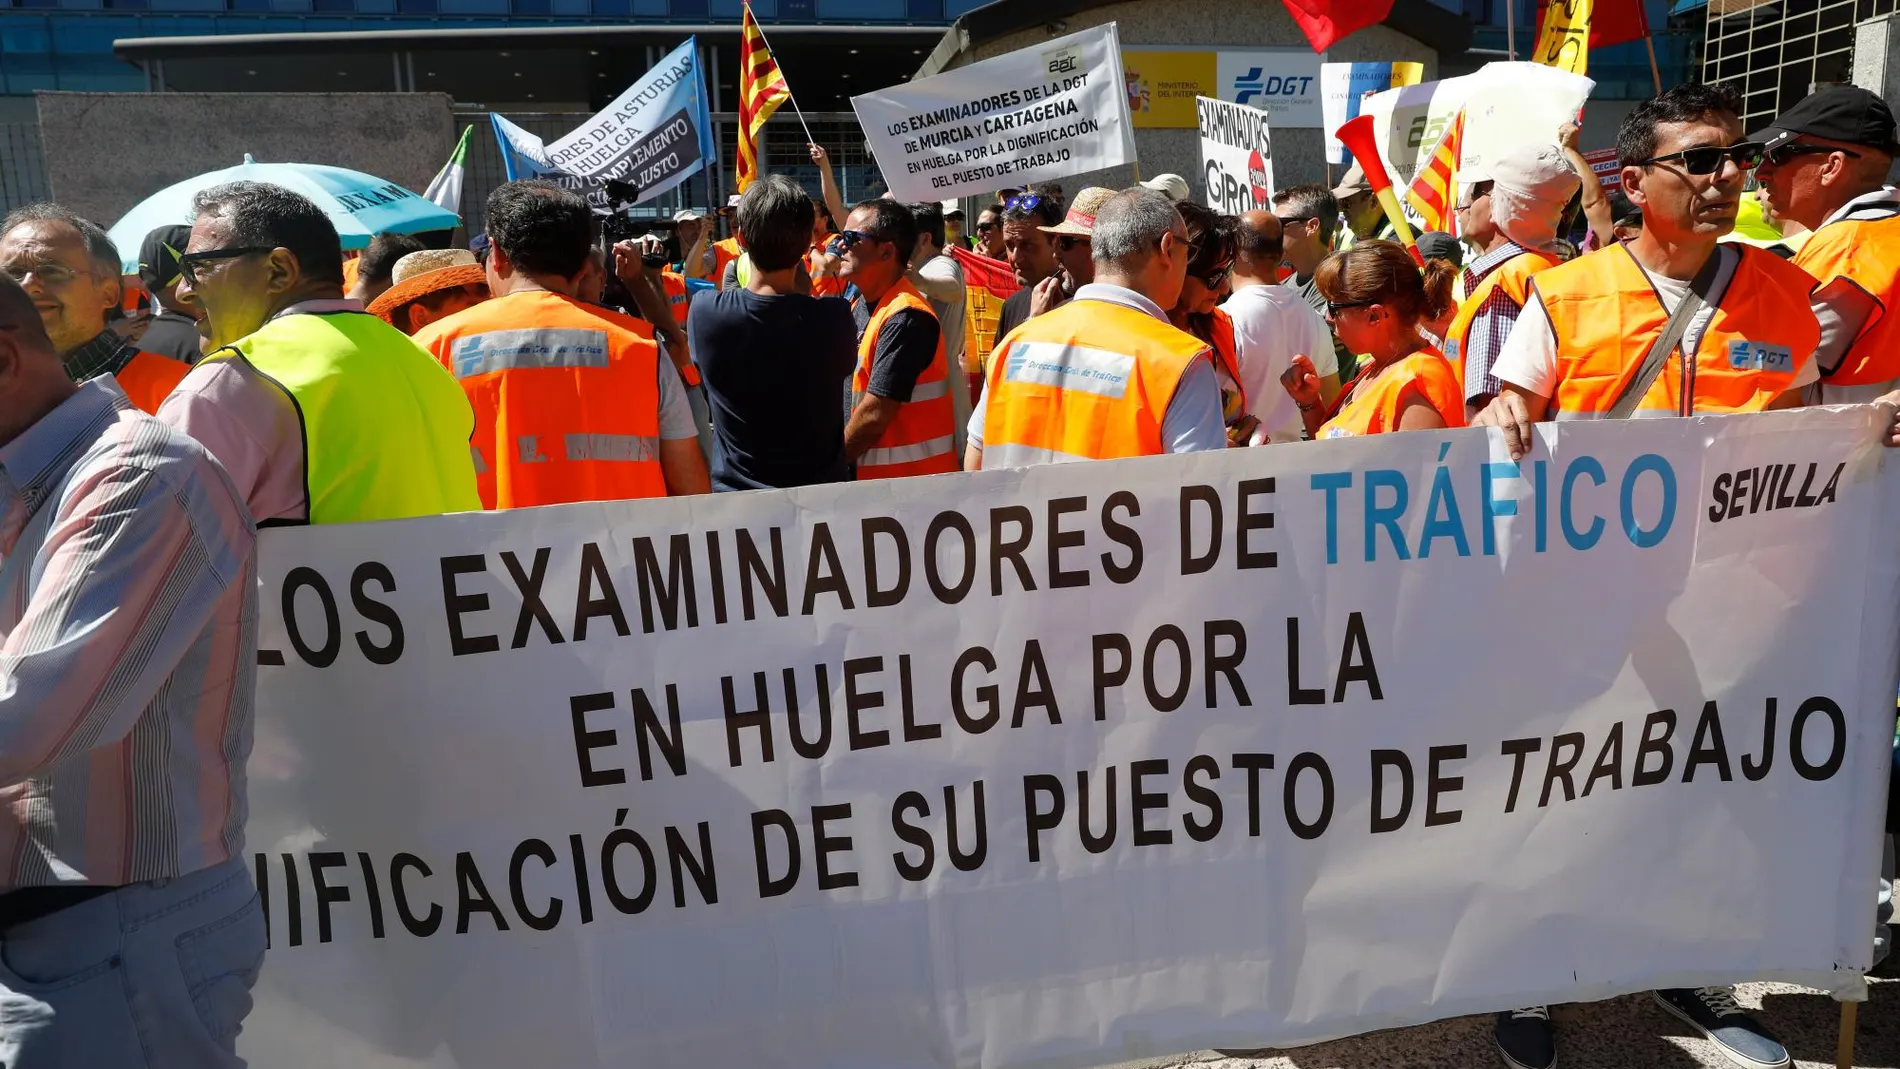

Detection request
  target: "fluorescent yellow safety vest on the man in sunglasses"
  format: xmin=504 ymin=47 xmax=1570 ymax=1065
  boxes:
xmin=225 ymin=311 xmax=481 ymax=524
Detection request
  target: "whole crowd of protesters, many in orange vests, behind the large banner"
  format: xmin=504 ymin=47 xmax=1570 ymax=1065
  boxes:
xmin=0 ymin=75 xmax=1900 ymax=1069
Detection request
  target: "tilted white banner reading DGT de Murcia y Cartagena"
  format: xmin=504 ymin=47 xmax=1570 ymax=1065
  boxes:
xmin=851 ymin=23 xmax=1134 ymax=201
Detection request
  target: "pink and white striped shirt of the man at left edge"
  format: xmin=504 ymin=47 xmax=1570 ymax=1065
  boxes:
xmin=0 ymin=376 xmax=257 ymax=891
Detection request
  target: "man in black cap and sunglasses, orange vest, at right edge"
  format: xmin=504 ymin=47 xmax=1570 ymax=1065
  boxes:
xmin=1756 ymin=85 xmax=1900 ymax=404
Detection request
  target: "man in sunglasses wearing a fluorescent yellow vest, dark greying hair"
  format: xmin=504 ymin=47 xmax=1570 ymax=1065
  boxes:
xmin=158 ymin=182 xmax=481 ymax=524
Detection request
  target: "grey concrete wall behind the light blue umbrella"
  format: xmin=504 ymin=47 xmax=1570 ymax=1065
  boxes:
xmin=38 ymin=93 xmax=454 ymax=228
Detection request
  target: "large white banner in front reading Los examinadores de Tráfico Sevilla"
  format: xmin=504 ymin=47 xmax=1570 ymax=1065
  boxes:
xmin=239 ymin=406 xmax=1900 ymax=1069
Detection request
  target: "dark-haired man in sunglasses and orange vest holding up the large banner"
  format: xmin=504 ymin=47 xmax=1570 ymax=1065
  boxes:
xmin=1476 ymin=85 xmax=1820 ymax=1069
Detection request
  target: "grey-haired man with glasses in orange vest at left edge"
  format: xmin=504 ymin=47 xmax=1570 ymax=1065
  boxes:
xmin=0 ymin=203 xmax=192 ymax=412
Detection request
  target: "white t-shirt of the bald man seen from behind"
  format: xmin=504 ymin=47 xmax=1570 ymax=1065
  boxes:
xmin=1220 ymin=285 xmax=1340 ymax=442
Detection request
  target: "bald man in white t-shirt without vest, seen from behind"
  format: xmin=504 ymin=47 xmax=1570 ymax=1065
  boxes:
xmin=1220 ymin=211 xmax=1340 ymax=444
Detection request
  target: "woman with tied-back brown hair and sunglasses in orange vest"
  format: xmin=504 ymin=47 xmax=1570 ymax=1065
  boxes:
xmin=1281 ymin=241 xmax=1465 ymax=439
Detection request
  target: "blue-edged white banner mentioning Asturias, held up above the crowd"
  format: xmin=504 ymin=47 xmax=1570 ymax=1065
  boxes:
xmin=547 ymin=38 xmax=716 ymax=203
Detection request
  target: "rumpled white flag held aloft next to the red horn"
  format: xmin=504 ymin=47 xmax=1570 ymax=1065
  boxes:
xmin=1360 ymin=63 xmax=1596 ymax=186
